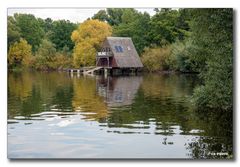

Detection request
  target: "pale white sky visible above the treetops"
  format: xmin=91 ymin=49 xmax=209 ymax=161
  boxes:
xmin=8 ymin=8 xmax=155 ymax=23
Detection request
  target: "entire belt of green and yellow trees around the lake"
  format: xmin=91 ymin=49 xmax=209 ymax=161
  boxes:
xmin=8 ymin=8 xmax=233 ymax=111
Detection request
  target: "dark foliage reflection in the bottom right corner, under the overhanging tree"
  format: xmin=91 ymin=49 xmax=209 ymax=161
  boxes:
xmin=187 ymin=112 xmax=233 ymax=158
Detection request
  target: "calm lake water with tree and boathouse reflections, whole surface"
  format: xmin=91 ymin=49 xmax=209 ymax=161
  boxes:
xmin=8 ymin=72 xmax=233 ymax=159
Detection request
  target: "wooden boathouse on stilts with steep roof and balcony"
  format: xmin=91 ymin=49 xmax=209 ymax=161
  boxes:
xmin=96 ymin=37 xmax=143 ymax=74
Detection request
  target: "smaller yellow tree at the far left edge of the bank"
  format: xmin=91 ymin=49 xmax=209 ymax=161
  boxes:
xmin=8 ymin=39 xmax=32 ymax=66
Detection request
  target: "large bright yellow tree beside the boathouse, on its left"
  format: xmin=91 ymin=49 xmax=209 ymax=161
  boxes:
xmin=71 ymin=20 xmax=112 ymax=67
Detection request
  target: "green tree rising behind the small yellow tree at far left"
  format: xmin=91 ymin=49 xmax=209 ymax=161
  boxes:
xmin=14 ymin=14 xmax=44 ymax=52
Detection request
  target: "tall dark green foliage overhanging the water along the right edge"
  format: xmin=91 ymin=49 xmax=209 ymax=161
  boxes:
xmin=192 ymin=9 xmax=233 ymax=112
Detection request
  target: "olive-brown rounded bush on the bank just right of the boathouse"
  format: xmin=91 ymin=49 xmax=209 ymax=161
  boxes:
xmin=141 ymin=46 xmax=171 ymax=72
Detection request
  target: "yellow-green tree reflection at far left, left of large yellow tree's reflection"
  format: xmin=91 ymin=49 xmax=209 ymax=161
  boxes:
xmin=8 ymin=72 xmax=72 ymax=118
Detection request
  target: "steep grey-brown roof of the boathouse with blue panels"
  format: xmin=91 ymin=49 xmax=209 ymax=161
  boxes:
xmin=106 ymin=37 xmax=143 ymax=68
